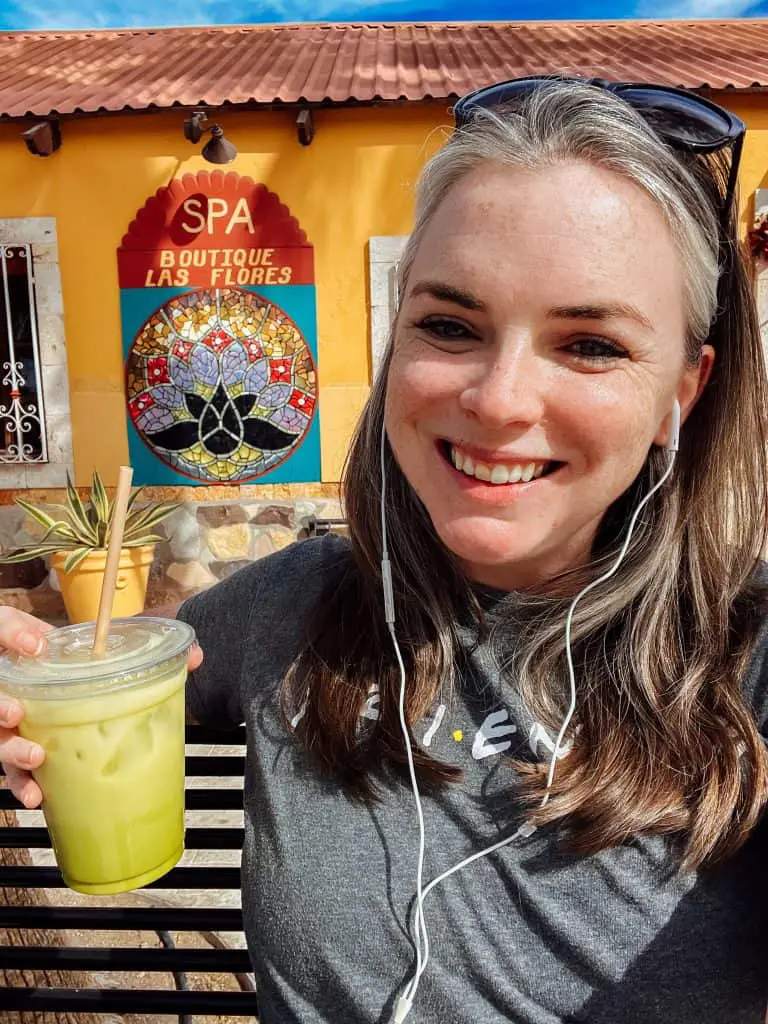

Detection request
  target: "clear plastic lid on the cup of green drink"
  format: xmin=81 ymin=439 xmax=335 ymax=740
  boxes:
xmin=0 ymin=615 xmax=195 ymax=690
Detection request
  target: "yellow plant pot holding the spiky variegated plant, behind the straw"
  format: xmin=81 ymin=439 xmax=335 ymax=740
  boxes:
xmin=50 ymin=544 xmax=155 ymax=623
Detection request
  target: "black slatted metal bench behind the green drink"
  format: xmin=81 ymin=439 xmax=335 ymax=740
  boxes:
xmin=0 ymin=726 xmax=257 ymax=1022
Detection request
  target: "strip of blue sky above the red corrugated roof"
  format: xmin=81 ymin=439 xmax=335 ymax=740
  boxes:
xmin=0 ymin=0 xmax=768 ymax=29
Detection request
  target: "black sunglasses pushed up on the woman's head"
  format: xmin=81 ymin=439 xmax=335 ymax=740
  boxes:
xmin=453 ymin=75 xmax=746 ymax=224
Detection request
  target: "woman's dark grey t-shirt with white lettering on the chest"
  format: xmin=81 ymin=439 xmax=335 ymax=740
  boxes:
xmin=179 ymin=537 xmax=768 ymax=1024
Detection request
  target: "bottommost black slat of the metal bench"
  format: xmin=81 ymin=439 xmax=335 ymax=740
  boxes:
xmin=2 ymin=988 xmax=258 ymax=1019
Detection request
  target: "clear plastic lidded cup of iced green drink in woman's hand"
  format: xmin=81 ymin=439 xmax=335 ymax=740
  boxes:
xmin=0 ymin=616 xmax=195 ymax=894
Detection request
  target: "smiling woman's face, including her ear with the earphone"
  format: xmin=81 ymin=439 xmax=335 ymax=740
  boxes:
xmin=386 ymin=162 xmax=712 ymax=589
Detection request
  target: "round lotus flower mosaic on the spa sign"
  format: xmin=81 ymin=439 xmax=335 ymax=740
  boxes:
xmin=126 ymin=288 xmax=316 ymax=483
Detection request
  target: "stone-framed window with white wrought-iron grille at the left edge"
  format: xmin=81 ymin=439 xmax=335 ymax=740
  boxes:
xmin=0 ymin=217 xmax=72 ymax=488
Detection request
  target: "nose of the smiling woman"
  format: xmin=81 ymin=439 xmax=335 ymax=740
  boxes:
xmin=460 ymin=344 xmax=544 ymax=429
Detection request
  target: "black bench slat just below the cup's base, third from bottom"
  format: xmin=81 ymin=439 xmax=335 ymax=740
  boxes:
xmin=0 ymin=906 xmax=243 ymax=933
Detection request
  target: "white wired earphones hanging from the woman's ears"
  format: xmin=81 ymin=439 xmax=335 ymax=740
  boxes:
xmin=381 ymin=399 xmax=680 ymax=1024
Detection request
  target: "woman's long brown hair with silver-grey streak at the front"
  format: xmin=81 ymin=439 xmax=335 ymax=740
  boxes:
xmin=284 ymin=83 xmax=768 ymax=868
